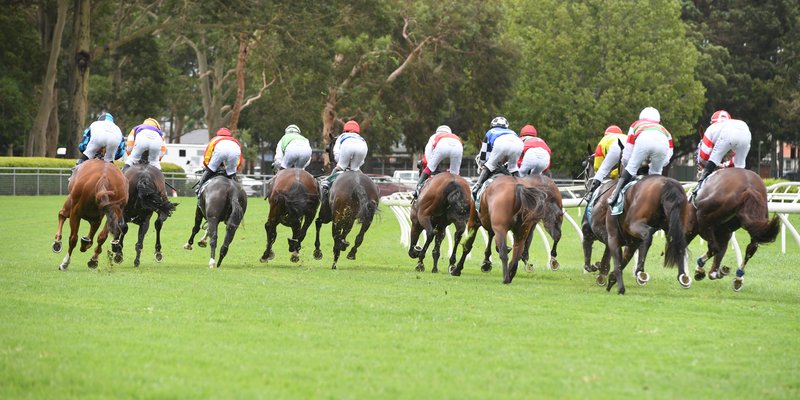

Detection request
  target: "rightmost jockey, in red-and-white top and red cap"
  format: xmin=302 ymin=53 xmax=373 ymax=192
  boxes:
xmin=692 ymin=110 xmax=751 ymax=196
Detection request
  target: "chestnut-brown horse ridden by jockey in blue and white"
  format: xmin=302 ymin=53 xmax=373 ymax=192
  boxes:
xmin=450 ymin=175 xmax=547 ymax=284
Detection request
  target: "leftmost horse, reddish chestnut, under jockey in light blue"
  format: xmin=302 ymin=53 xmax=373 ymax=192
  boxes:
xmin=53 ymin=160 xmax=128 ymax=271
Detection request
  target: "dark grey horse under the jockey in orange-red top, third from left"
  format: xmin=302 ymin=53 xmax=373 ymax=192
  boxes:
xmin=183 ymin=175 xmax=247 ymax=268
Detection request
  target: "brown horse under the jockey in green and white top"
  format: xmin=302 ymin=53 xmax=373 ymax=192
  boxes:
xmin=261 ymin=168 xmax=320 ymax=263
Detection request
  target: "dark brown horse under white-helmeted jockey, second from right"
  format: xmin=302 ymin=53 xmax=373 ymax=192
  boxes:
xmin=598 ymin=175 xmax=692 ymax=294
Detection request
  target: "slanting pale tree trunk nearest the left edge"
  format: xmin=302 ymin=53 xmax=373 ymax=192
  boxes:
xmin=26 ymin=0 xmax=69 ymax=157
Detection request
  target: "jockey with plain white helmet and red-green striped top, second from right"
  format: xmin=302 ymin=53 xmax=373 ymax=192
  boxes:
xmin=608 ymin=107 xmax=672 ymax=205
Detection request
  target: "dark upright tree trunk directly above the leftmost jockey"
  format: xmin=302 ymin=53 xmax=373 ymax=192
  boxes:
xmin=66 ymin=0 xmax=92 ymax=157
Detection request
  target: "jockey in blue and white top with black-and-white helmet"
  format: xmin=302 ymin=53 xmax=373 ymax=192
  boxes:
xmin=472 ymin=116 xmax=525 ymax=197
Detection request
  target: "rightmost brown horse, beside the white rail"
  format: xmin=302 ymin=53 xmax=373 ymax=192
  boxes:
xmin=686 ymin=168 xmax=780 ymax=291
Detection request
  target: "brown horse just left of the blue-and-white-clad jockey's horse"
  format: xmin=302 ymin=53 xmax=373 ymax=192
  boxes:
xmin=408 ymin=172 xmax=475 ymax=273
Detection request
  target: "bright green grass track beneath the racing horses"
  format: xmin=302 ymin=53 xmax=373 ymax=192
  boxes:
xmin=0 ymin=197 xmax=800 ymax=399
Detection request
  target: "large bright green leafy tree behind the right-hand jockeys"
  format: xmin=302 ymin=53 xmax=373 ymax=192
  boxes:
xmin=506 ymin=0 xmax=704 ymax=173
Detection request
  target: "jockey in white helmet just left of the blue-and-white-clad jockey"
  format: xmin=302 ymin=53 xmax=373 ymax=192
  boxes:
xmin=414 ymin=125 xmax=464 ymax=199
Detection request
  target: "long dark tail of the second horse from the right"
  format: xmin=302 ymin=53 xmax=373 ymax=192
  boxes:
xmin=661 ymin=179 xmax=687 ymax=267
